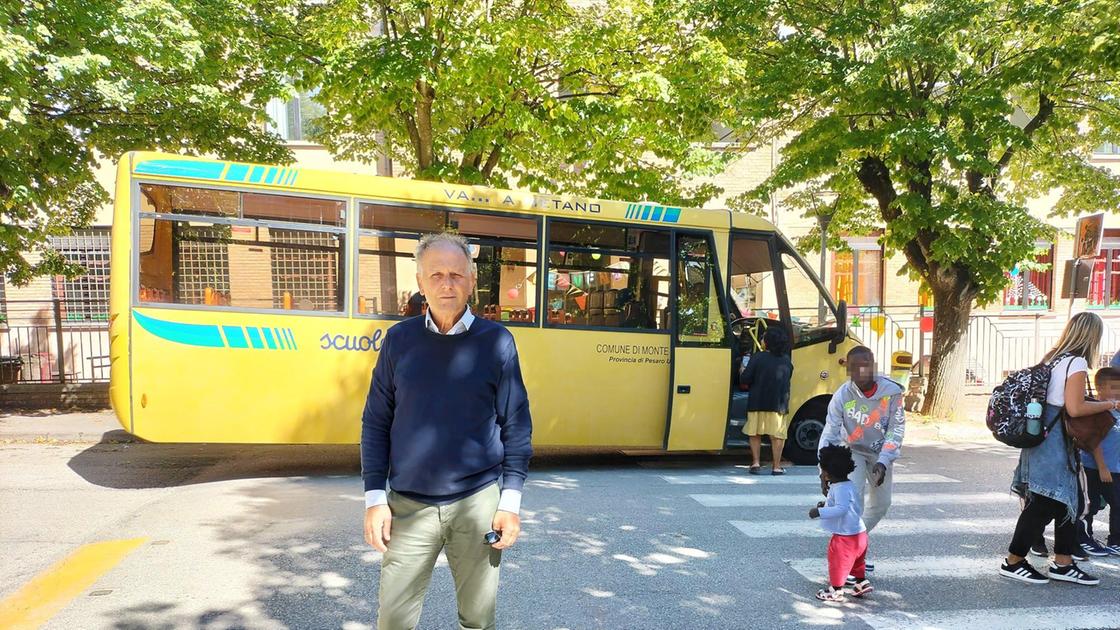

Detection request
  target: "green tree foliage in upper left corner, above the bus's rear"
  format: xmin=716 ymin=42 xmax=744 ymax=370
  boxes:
xmin=0 ymin=0 xmax=290 ymax=284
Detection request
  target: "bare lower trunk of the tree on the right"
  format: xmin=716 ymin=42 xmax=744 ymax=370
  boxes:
xmin=920 ymin=282 xmax=973 ymax=418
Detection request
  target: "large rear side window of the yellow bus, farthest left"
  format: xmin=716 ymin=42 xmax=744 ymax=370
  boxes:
xmin=137 ymin=184 xmax=346 ymax=312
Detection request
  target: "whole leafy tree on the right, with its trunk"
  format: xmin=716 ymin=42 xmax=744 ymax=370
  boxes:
xmin=699 ymin=0 xmax=1120 ymax=413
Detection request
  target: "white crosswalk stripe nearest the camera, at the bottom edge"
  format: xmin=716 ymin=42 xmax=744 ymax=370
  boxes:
xmin=859 ymin=604 xmax=1120 ymax=630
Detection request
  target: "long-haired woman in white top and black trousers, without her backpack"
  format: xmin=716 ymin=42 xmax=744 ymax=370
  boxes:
xmin=999 ymin=313 xmax=1120 ymax=585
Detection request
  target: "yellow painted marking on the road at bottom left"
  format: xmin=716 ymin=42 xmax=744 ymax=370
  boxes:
xmin=0 ymin=538 xmax=148 ymax=629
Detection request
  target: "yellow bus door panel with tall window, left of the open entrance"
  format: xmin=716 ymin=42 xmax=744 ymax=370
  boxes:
xmin=665 ymin=231 xmax=731 ymax=451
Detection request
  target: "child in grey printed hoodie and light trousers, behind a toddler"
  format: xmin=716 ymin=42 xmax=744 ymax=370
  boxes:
xmin=818 ymin=345 xmax=906 ymax=532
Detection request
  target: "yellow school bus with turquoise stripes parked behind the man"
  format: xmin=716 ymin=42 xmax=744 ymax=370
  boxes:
xmin=110 ymin=152 xmax=855 ymax=462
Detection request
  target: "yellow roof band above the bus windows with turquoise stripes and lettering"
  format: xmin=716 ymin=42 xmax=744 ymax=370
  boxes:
xmin=121 ymin=151 xmax=775 ymax=232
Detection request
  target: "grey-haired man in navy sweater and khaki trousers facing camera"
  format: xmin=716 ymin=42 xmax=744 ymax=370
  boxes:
xmin=362 ymin=234 xmax=532 ymax=630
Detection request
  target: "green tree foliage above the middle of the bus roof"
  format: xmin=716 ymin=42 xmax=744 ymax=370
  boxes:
xmin=262 ymin=0 xmax=743 ymax=204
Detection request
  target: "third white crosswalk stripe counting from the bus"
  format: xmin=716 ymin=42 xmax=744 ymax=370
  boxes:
xmin=730 ymin=509 xmax=1016 ymax=538
